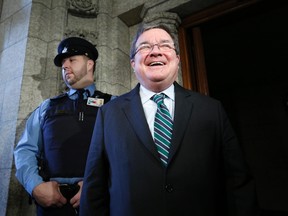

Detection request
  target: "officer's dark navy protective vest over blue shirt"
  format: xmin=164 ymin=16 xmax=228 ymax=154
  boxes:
xmin=42 ymin=91 xmax=111 ymax=178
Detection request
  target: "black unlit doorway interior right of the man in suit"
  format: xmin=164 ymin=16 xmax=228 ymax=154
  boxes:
xmin=201 ymin=0 xmax=288 ymax=216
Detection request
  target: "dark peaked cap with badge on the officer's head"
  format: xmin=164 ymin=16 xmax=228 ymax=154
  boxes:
xmin=54 ymin=37 xmax=98 ymax=67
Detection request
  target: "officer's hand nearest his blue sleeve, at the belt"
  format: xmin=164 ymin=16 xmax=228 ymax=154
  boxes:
xmin=32 ymin=181 xmax=67 ymax=207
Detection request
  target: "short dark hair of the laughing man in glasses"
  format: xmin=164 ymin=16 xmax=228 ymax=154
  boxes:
xmin=130 ymin=24 xmax=179 ymax=60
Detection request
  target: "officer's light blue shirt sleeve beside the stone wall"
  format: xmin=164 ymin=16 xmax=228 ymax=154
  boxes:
xmin=14 ymin=102 xmax=46 ymax=195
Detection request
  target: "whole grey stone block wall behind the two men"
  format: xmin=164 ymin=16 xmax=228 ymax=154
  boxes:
xmin=0 ymin=0 xmax=216 ymax=216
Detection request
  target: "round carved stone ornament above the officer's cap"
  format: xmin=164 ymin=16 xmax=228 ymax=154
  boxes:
xmin=67 ymin=0 xmax=99 ymax=18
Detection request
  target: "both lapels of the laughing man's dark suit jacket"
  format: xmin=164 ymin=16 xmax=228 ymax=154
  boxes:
xmin=121 ymin=83 xmax=193 ymax=164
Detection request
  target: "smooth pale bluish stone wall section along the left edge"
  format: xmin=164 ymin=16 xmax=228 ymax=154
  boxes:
xmin=0 ymin=0 xmax=32 ymax=215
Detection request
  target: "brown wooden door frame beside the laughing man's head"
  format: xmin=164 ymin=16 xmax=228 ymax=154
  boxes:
xmin=178 ymin=0 xmax=261 ymax=95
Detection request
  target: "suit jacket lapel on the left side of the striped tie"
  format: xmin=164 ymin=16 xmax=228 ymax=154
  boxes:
xmin=122 ymin=84 xmax=160 ymax=161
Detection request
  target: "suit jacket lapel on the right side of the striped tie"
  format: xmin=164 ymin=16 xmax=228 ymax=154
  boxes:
xmin=168 ymin=83 xmax=193 ymax=164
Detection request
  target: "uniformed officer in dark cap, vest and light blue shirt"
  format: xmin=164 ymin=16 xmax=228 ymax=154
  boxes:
xmin=14 ymin=37 xmax=113 ymax=216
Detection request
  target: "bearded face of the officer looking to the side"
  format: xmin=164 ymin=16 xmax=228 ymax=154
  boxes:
xmin=62 ymin=55 xmax=94 ymax=89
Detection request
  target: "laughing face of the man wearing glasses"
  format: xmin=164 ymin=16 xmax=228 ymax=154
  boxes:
xmin=131 ymin=28 xmax=180 ymax=91
